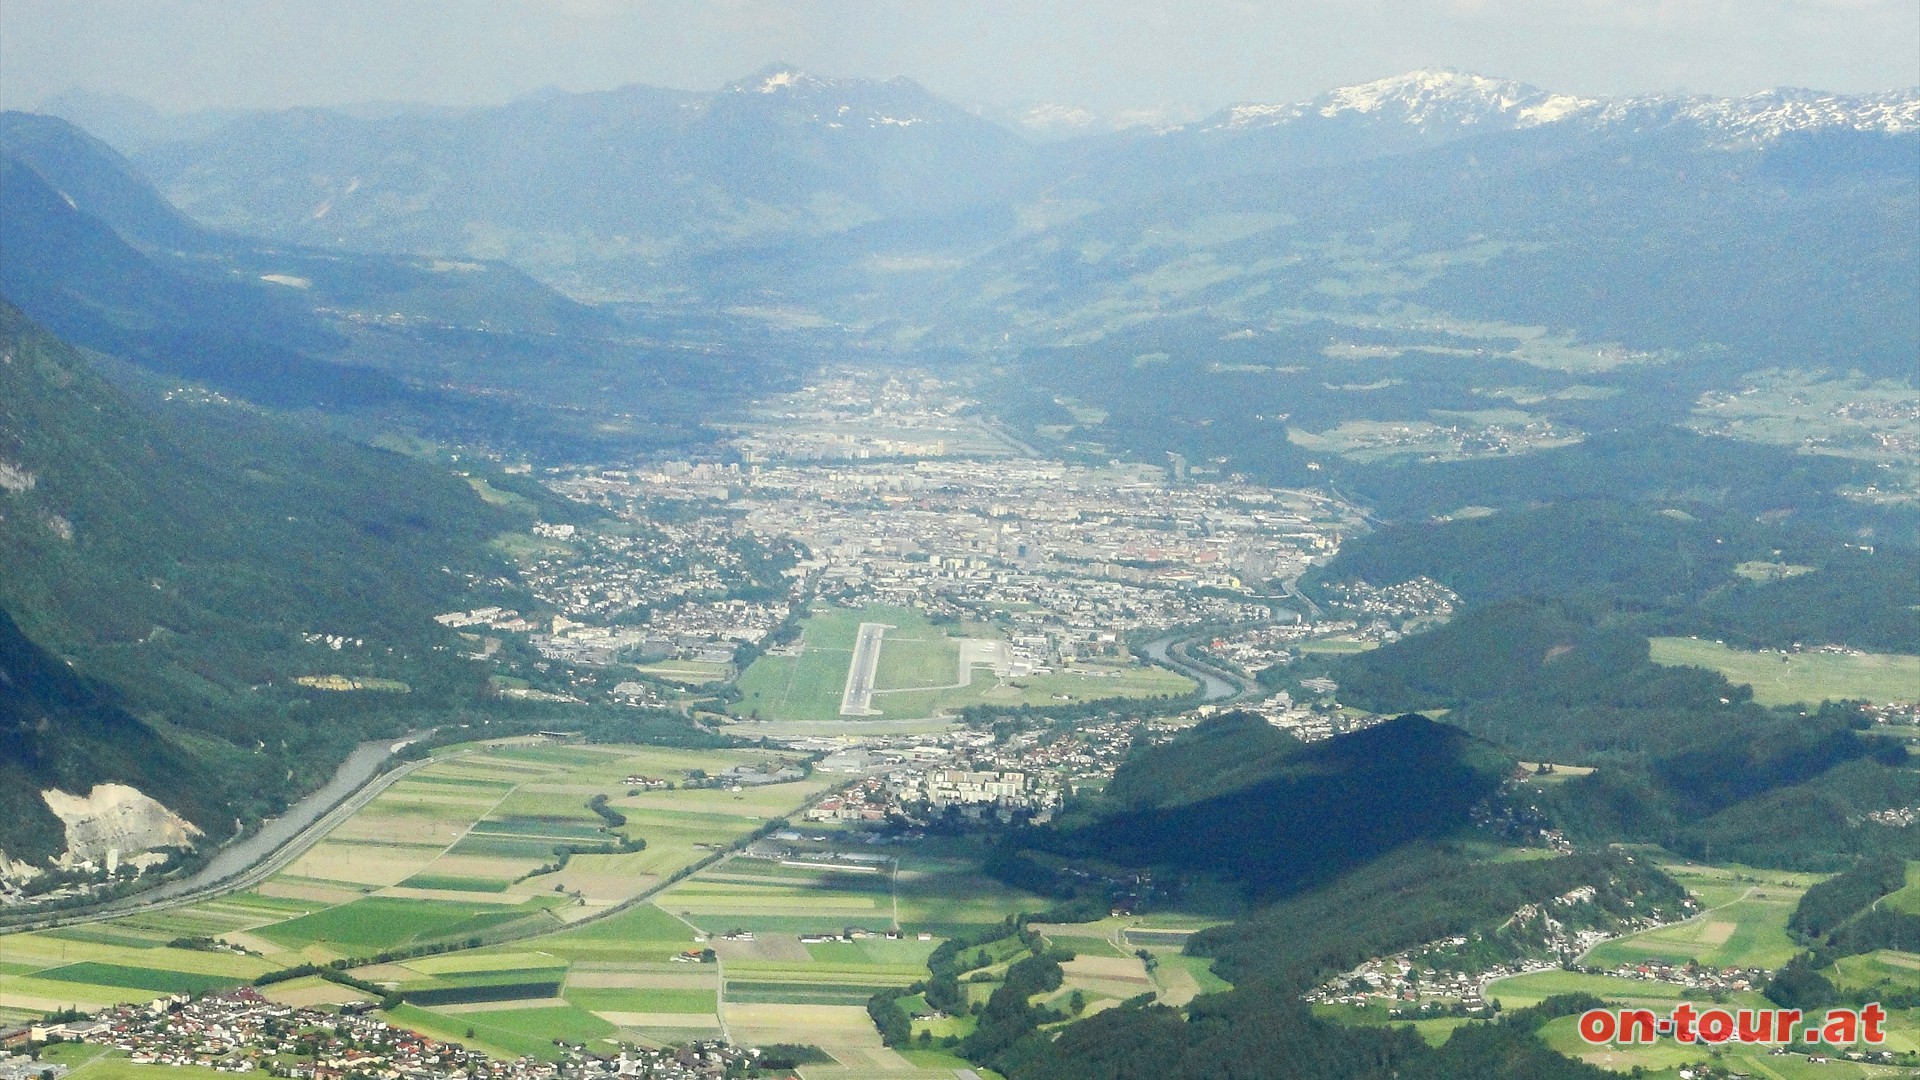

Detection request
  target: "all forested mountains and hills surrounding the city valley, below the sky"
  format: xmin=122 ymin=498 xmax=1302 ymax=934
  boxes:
xmin=0 ymin=65 xmax=1920 ymax=1080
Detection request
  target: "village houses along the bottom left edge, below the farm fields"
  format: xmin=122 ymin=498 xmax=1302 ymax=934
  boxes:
xmin=11 ymin=988 xmax=760 ymax=1080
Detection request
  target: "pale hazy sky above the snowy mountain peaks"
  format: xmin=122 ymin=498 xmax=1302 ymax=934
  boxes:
xmin=0 ymin=0 xmax=1920 ymax=111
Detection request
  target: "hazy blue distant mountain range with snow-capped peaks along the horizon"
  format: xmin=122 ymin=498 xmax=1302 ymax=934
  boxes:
xmin=48 ymin=65 xmax=1920 ymax=378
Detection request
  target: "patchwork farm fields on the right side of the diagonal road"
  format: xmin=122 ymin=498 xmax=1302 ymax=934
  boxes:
xmin=368 ymin=834 xmax=1052 ymax=1076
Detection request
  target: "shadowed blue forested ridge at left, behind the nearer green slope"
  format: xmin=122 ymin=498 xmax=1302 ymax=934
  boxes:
xmin=0 ymin=113 xmax=814 ymax=455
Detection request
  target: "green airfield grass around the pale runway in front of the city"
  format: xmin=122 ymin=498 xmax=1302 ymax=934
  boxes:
xmin=733 ymin=605 xmax=1192 ymax=723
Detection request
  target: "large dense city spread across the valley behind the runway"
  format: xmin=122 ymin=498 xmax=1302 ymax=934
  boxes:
xmin=503 ymin=377 xmax=1359 ymax=669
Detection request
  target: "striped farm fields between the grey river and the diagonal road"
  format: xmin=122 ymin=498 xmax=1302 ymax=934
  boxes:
xmin=0 ymin=734 xmax=831 ymax=1022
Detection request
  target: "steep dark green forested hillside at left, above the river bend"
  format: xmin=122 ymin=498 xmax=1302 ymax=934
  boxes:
xmin=0 ymin=304 xmax=511 ymax=857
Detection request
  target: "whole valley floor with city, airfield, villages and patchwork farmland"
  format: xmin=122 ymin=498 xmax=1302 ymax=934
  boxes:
xmin=0 ymin=371 xmax=1912 ymax=1080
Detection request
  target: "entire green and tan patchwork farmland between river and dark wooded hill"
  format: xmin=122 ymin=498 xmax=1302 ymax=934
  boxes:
xmin=0 ymin=744 xmax=1052 ymax=1080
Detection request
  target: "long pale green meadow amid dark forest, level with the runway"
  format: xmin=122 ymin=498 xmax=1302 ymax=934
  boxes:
xmin=1653 ymin=638 xmax=1920 ymax=705
